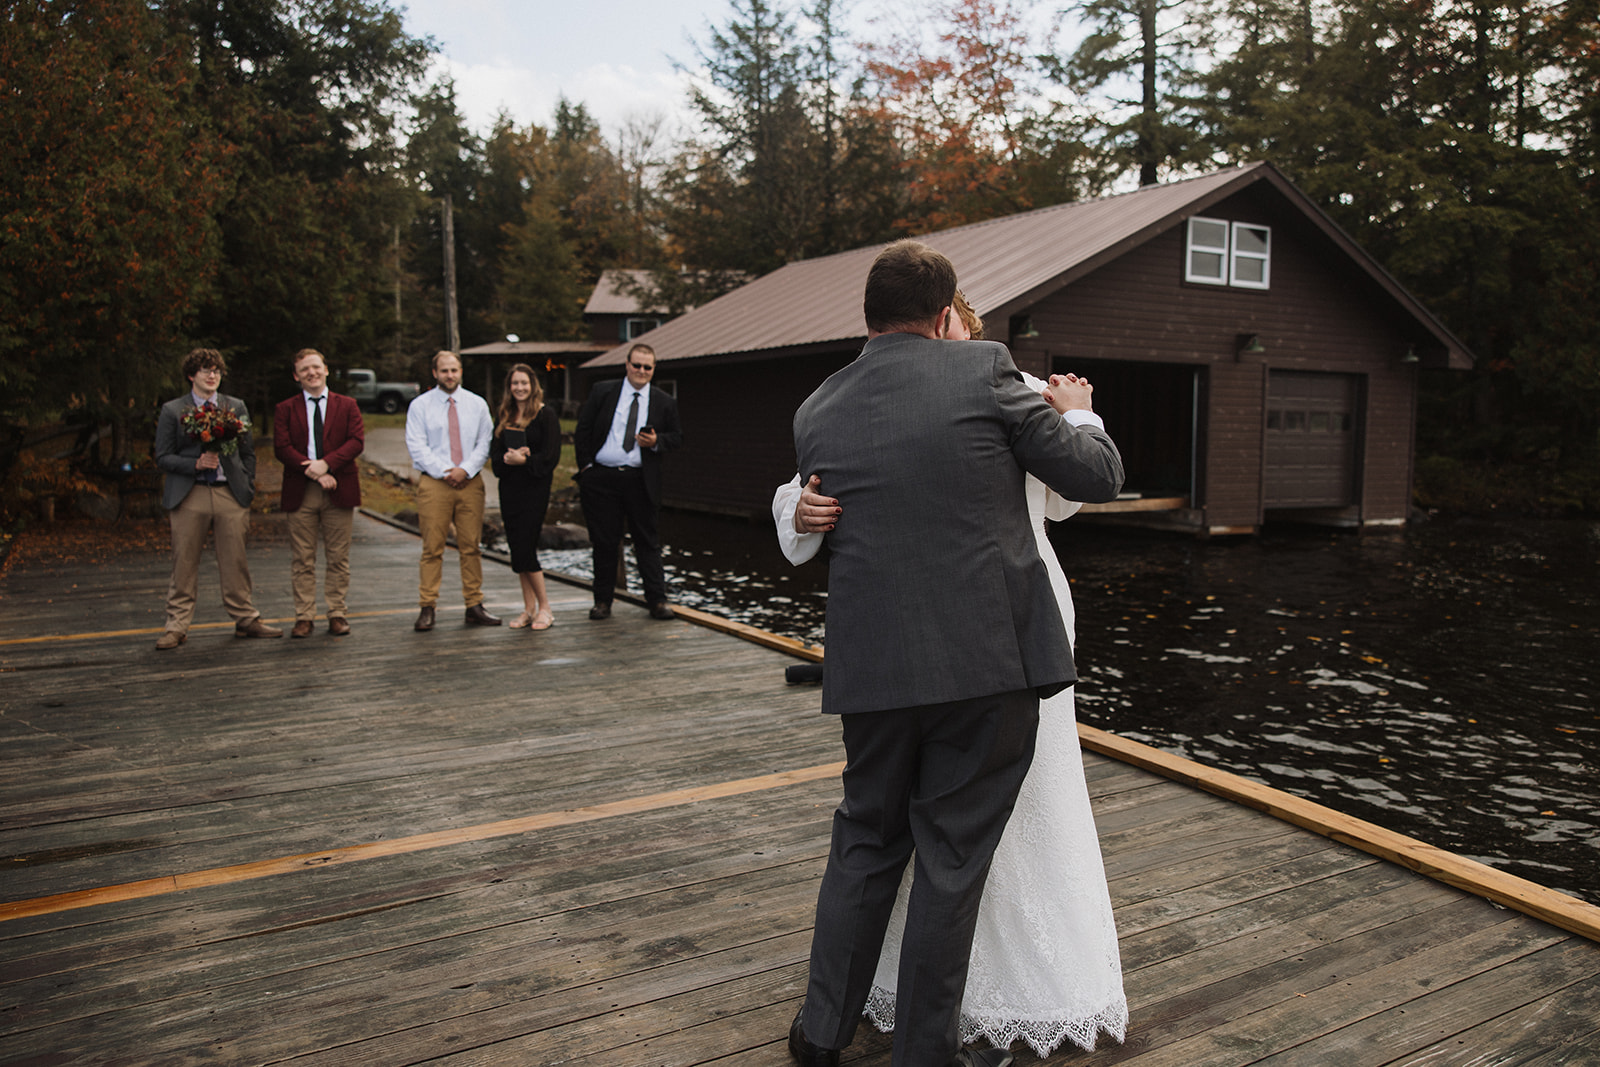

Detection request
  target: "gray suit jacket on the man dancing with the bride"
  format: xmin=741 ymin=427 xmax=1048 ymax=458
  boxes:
xmin=794 ymin=333 xmax=1123 ymax=713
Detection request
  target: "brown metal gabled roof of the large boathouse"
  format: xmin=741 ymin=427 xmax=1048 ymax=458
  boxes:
xmin=584 ymin=163 xmax=1472 ymax=368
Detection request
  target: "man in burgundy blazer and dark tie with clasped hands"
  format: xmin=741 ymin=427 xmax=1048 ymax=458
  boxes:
xmin=272 ymin=349 xmax=366 ymax=637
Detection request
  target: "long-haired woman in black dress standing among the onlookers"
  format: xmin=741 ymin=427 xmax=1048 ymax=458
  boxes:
xmin=490 ymin=363 xmax=562 ymax=630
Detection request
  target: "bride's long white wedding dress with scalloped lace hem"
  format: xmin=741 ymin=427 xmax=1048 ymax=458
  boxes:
xmin=866 ymin=473 xmax=1128 ymax=1057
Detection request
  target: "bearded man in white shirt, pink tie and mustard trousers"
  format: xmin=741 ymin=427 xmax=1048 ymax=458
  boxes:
xmin=405 ymin=350 xmax=501 ymax=632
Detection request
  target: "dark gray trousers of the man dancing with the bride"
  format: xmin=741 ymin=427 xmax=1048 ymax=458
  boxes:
xmin=802 ymin=689 xmax=1038 ymax=1067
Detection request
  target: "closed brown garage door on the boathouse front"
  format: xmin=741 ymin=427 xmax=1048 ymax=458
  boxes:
xmin=1264 ymin=371 xmax=1358 ymax=507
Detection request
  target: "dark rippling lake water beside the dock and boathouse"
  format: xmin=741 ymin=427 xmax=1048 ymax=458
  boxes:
xmin=541 ymin=514 xmax=1600 ymax=904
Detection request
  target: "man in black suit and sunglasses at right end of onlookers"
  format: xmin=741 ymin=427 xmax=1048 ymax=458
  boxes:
xmin=573 ymin=344 xmax=683 ymax=619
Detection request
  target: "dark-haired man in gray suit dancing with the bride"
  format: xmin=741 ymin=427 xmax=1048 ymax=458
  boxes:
xmin=789 ymin=242 xmax=1123 ymax=1067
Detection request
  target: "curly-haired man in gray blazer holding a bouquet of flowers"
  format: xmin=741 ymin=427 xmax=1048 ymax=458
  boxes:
xmin=155 ymin=349 xmax=283 ymax=651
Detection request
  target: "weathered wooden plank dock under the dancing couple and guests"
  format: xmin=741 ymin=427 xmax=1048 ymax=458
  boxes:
xmin=0 ymin=520 xmax=1600 ymax=1067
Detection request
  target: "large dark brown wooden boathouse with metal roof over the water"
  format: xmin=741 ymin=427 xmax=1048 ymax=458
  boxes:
xmin=584 ymin=163 xmax=1472 ymax=534
